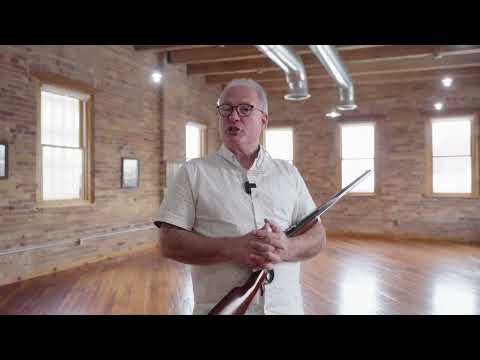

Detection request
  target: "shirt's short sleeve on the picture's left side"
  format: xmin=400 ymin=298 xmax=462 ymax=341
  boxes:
xmin=154 ymin=165 xmax=195 ymax=231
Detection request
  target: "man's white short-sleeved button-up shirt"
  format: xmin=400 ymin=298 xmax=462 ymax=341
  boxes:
xmin=154 ymin=145 xmax=316 ymax=314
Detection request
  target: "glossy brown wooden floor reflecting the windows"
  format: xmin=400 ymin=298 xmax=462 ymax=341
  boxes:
xmin=0 ymin=238 xmax=480 ymax=314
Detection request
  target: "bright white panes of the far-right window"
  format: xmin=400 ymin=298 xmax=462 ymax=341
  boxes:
xmin=429 ymin=116 xmax=476 ymax=195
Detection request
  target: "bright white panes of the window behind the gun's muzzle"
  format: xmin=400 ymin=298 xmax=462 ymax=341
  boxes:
xmin=340 ymin=122 xmax=375 ymax=193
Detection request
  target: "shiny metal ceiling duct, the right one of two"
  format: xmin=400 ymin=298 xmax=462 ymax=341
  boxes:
xmin=309 ymin=45 xmax=357 ymax=111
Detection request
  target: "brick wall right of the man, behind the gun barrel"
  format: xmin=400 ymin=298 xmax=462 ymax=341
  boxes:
xmin=269 ymin=78 xmax=480 ymax=241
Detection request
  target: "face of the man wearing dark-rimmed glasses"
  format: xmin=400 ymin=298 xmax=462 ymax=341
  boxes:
xmin=220 ymin=85 xmax=268 ymax=147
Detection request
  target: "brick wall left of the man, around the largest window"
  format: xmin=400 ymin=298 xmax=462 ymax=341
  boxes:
xmin=0 ymin=45 xmax=164 ymax=284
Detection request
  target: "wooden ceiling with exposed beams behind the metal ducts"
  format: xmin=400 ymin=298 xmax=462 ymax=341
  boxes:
xmin=134 ymin=45 xmax=480 ymax=92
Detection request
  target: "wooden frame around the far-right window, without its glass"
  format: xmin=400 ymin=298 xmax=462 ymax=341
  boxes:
xmin=423 ymin=111 xmax=480 ymax=198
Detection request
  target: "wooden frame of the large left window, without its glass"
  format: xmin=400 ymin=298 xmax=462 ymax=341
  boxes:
xmin=32 ymin=73 xmax=95 ymax=208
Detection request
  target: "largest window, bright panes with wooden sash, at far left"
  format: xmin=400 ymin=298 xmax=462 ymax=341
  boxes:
xmin=38 ymin=76 xmax=93 ymax=205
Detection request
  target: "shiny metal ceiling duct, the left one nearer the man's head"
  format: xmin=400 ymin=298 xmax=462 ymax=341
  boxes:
xmin=255 ymin=45 xmax=311 ymax=101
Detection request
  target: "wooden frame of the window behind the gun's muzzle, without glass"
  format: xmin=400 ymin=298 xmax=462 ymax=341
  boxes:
xmin=336 ymin=116 xmax=381 ymax=197
